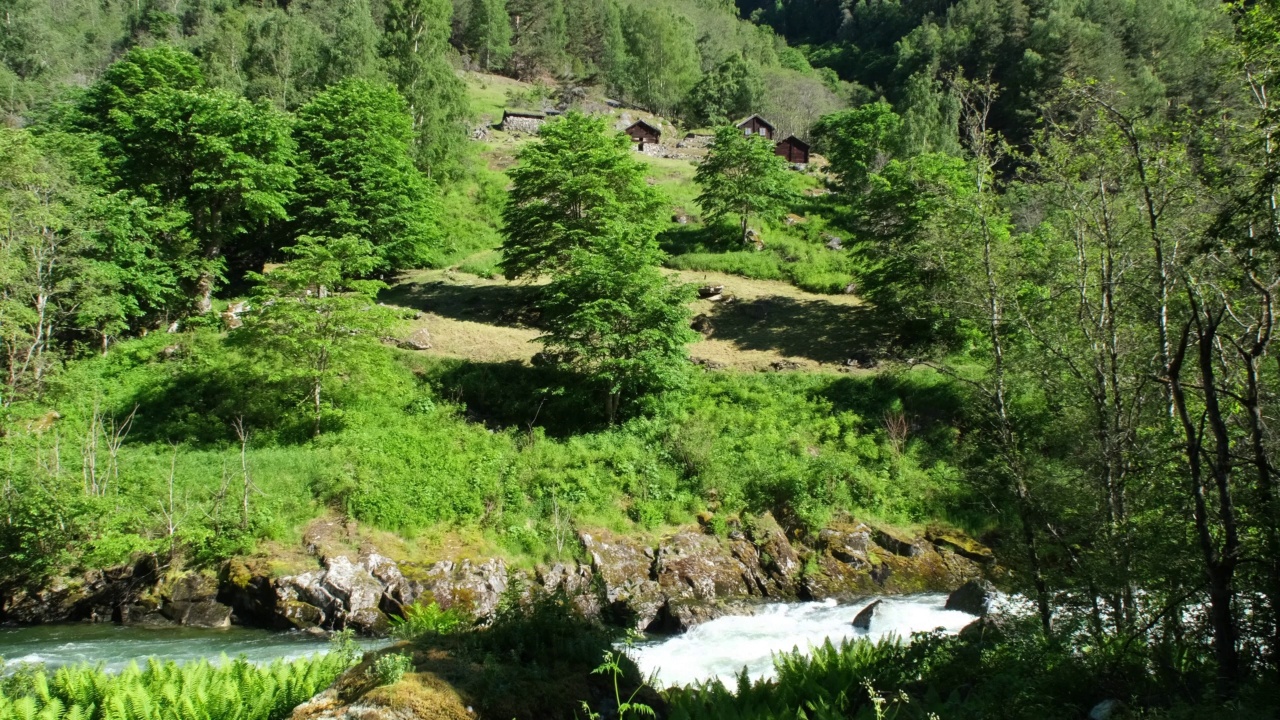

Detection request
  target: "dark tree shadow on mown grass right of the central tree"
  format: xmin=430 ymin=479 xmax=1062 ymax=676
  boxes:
xmin=708 ymin=296 xmax=893 ymax=364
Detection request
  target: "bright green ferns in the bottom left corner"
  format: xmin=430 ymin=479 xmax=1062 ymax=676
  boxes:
xmin=0 ymin=655 xmax=349 ymax=720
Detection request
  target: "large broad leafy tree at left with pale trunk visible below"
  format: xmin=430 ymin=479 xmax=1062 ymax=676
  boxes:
xmin=78 ymin=46 xmax=294 ymax=313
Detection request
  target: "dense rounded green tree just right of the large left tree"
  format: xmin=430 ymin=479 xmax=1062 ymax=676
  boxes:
xmin=293 ymin=79 xmax=439 ymax=272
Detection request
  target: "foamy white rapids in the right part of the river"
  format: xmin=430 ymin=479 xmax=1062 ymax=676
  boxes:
xmin=631 ymin=594 xmax=975 ymax=688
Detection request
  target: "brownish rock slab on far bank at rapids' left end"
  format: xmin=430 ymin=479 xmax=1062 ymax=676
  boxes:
xmin=579 ymin=530 xmax=666 ymax=630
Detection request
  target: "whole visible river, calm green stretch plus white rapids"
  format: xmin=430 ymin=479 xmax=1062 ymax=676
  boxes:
xmin=0 ymin=594 xmax=974 ymax=687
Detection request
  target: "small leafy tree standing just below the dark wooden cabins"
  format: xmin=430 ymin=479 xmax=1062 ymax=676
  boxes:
xmin=694 ymin=126 xmax=794 ymax=242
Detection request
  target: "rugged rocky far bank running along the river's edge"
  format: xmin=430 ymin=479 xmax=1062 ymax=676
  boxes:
xmin=0 ymin=514 xmax=995 ymax=635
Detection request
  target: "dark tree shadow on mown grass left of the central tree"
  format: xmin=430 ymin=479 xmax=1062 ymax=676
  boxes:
xmin=378 ymin=281 xmax=538 ymax=327
